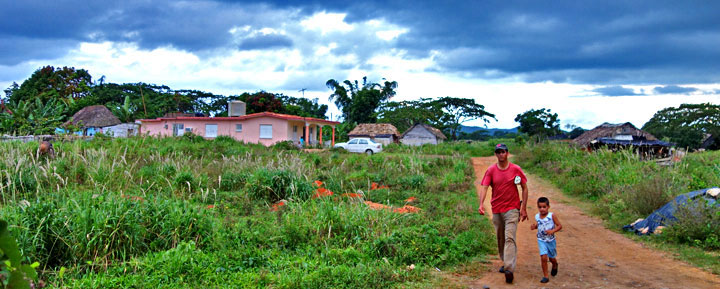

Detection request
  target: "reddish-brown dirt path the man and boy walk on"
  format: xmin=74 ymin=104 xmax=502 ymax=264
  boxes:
xmin=468 ymin=157 xmax=720 ymax=288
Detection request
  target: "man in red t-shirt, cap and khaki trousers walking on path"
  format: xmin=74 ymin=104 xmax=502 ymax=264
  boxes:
xmin=478 ymin=144 xmax=528 ymax=283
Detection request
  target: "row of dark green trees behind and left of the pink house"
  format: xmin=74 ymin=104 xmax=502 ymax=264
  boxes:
xmin=0 ymin=66 xmax=328 ymax=134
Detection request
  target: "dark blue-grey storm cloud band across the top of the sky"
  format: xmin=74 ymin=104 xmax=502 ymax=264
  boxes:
xmin=0 ymin=0 xmax=720 ymax=85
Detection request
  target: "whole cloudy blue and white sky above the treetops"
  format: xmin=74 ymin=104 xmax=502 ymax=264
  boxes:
xmin=0 ymin=0 xmax=720 ymax=128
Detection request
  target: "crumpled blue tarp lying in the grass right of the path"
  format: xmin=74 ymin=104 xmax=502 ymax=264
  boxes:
xmin=623 ymin=188 xmax=720 ymax=235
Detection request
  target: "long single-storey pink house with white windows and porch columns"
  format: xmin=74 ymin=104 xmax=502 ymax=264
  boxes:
xmin=137 ymin=112 xmax=339 ymax=146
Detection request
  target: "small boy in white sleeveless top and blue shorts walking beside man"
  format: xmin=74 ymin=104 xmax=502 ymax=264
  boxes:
xmin=530 ymin=197 xmax=562 ymax=283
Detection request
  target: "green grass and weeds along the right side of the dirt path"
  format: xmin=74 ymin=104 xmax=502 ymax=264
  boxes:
xmin=515 ymin=142 xmax=720 ymax=274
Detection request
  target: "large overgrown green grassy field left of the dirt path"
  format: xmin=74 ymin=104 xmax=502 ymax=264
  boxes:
xmin=0 ymin=134 xmax=494 ymax=288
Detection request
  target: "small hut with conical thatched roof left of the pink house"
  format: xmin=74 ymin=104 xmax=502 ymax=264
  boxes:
xmin=62 ymin=105 xmax=121 ymax=136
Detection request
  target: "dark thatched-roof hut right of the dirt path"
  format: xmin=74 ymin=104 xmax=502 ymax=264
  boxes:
xmin=572 ymin=122 xmax=673 ymax=157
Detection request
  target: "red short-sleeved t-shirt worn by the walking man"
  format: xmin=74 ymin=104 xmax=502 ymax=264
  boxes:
xmin=481 ymin=163 xmax=527 ymax=214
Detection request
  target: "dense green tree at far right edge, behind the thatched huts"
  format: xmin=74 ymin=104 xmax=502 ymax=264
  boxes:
xmin=642 ymin=103 xmax=720 ymax=149
